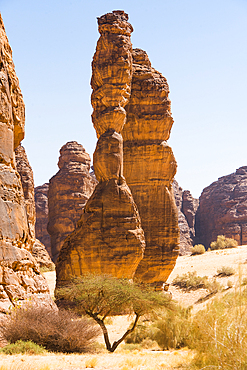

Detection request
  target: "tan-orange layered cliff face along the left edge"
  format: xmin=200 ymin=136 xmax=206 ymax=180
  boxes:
xmin=0 ymin=15 xmax=54 ymax=313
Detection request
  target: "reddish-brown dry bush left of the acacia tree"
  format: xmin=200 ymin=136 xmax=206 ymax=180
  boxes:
xmin=1 ymin=305 xmax=99 ymax=353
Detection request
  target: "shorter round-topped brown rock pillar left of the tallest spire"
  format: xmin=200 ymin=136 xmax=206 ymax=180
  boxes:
xmin=47 ymin=141 xmax=97 ymax=262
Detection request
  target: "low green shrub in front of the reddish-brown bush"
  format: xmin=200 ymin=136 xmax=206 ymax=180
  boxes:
xmin=0 ymin=340 xmax=47 ymax=355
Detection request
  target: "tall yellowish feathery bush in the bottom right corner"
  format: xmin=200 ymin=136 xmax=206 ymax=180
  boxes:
xmin=188 ymin=287 xmax=247 ymax=370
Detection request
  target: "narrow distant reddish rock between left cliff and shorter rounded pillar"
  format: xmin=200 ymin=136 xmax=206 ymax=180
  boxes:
xmin=34 ymin=183 xmax=52 ymax=257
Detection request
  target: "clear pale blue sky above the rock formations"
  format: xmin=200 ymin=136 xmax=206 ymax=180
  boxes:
xmin=0 ymin=0 xmax=247 ymax=197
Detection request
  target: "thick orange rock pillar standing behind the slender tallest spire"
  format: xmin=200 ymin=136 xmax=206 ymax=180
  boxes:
xmin=123 ymin=49 xmax=179 ymax=288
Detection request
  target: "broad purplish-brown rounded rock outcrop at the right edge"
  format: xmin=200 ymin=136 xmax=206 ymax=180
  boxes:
xmin=195 ymin=166 xmax=247 ymax=248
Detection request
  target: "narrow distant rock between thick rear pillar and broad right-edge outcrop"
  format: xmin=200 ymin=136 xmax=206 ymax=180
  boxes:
xmin=172 ymin=180 xmax=199 ymax=255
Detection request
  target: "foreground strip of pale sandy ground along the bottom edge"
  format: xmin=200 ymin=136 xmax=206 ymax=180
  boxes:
xmin=0 ymin=349 xmax=194 ymax=370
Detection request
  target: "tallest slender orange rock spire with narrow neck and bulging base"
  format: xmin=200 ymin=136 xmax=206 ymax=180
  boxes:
xmin=57 ymin=11 xmax=145 ymax=286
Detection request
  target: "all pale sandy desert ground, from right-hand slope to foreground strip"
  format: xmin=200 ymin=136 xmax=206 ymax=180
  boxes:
xmin=0 ymin=246 xmax=247 ymax=370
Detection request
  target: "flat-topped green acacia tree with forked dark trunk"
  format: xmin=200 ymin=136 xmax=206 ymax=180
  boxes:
xmin=56 ymin=274 xmax=171 ymax=352
